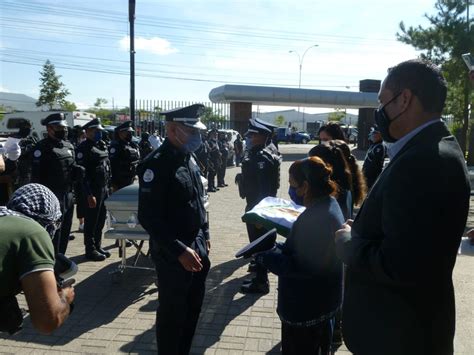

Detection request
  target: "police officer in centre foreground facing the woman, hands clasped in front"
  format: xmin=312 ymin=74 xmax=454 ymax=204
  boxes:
xmin=138 ymin=104 xmax=210 ymax=355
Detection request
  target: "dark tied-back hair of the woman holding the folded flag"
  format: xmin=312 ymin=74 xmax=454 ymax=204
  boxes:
xmin=289 ymin=157 xmax=338 ymax=198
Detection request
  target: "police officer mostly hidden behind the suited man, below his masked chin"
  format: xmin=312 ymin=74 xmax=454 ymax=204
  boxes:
xmin=362 ymin=126 xmax=387 ymax=189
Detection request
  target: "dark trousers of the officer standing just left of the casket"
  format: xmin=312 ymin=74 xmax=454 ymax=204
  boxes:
xmin=84 ymin=189 xmax=107 ymax=253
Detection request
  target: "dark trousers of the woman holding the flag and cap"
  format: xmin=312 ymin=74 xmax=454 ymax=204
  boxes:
xmin=281 ymin=318 xmax=334 ymax=355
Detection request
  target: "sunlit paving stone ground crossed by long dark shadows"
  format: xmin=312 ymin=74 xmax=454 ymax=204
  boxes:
xmin=0 ymin=145 xmax=474 ymax=355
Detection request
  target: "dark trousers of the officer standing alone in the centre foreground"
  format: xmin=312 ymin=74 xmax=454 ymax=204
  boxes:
xmin=154 ymin=256 xmax=210 ymax=355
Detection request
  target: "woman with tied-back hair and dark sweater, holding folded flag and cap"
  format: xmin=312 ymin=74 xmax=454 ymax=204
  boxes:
xmin=256 ymin=157 xmax=344 ymax=355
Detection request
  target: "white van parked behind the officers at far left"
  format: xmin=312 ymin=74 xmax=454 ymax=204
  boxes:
xmin=0 ymin=111 xmax=95 ymax=139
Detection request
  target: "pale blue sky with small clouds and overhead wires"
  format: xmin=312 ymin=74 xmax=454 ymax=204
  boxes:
xmin=0 ymin=0 xmax=464 ymax=112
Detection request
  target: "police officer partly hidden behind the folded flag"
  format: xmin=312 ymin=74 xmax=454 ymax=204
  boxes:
xmin=236 ymin=118 xmax=282 ymax=293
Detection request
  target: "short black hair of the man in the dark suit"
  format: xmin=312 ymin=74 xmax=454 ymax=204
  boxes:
xmin=385 ymin=59 xmax=448 ymax=113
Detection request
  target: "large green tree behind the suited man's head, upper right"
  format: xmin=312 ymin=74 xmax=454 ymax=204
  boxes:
xmin=397 ymin=0 xmax=474 ymax=163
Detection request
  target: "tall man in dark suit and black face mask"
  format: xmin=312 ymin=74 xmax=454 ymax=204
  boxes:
xmin=336 ymin=60 xmax=470 ymax=355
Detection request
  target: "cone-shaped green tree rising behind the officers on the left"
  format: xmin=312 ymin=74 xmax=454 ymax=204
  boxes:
xmin=36 ymin=59 xmax=70 ymax=110
